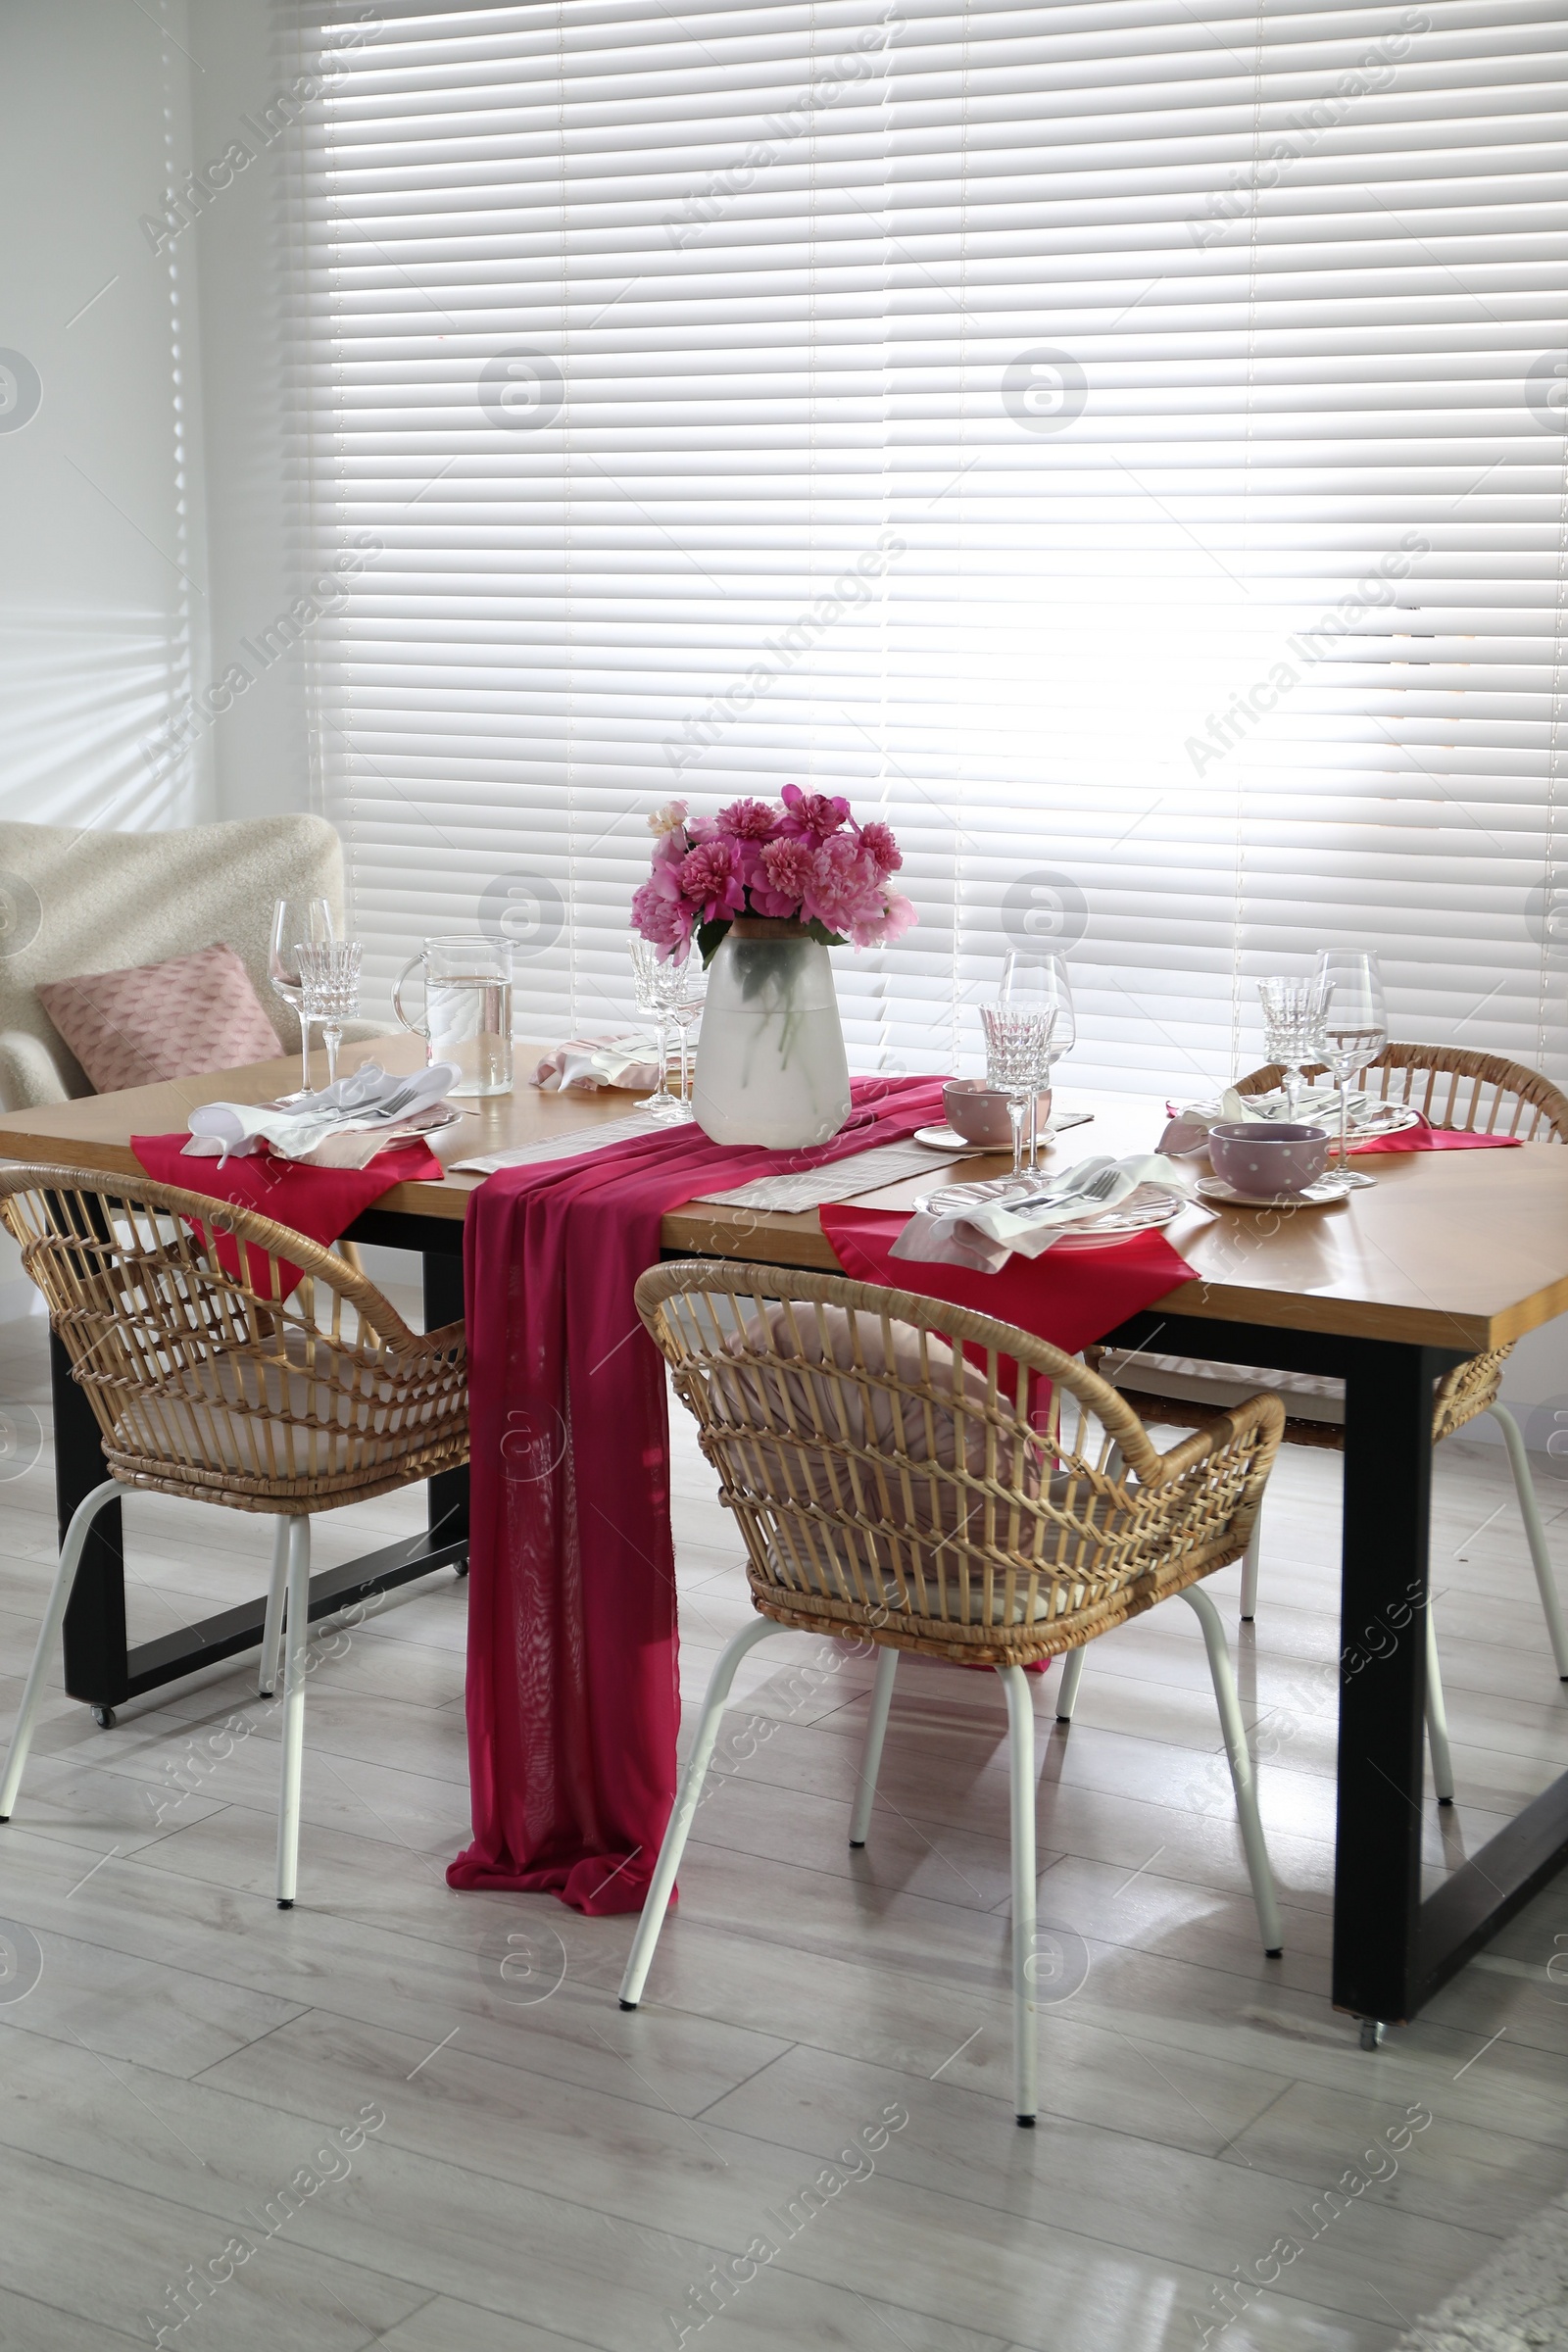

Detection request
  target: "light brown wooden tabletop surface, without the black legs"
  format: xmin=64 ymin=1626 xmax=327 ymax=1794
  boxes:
xmin=0 ymin=1035 xmax=1568 ymax=1352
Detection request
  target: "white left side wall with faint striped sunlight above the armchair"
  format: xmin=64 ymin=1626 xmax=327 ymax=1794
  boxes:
xmin=0 ymin=0 xmax=217 ymax=828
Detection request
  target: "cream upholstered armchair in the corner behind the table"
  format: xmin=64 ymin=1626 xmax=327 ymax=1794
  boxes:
xmin=0 ymin=816 xmax=378 ymax=1110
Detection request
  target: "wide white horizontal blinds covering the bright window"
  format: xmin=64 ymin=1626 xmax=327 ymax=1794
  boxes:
xmin=301 ymin=0 xmax=1568 ymax=1089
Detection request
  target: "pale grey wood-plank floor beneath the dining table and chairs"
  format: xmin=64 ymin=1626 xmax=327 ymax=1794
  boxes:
xmin=0 ymin=1322 xmax=1568 ymax=2352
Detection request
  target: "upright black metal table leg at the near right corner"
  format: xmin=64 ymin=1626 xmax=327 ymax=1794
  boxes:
xmin=1333 ymin=1341 xmax=1448 ymax=2028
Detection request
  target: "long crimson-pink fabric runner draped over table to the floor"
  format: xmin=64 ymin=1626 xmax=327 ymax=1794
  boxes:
xmin=447 ymin=1080 xmax=941 ymax=1915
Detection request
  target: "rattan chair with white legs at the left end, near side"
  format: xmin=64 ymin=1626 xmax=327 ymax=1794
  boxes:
xmin=0 ymin=1166 xmax=467 ymax=1910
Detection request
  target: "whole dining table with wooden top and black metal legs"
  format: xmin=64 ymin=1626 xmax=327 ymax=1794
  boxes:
xmin=0 ymin=1037 xmax=1568 ymax=2041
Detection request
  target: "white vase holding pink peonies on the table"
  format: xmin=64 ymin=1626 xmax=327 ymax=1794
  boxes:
xmin=691 ymin=915 xmax=849 ymax=1151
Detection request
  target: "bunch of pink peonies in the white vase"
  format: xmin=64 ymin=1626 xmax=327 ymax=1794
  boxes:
xmin=632 ymin=783 xmax=917 ymax=964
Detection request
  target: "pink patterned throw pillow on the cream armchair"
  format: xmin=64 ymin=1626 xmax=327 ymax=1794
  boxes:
xmin=37 ymin=948 xmax=282 ymax=1094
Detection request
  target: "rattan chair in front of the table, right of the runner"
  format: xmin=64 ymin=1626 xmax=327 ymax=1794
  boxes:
xmin=620 ymin=1263 xmax=1284 ymax=2124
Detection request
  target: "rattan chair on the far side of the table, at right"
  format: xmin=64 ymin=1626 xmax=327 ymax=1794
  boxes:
xmin=1100 ymin=1045 xmax=1568 ymax=1804
